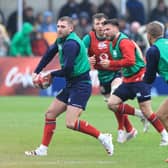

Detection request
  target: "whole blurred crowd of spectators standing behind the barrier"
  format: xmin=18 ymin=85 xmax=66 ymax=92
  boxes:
xmin=0 ymin=0 xmax=168 ymax=57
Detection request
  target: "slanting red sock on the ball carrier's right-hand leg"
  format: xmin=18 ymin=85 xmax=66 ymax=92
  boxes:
xmin=74 ymin=120 xmax=100 ymax=138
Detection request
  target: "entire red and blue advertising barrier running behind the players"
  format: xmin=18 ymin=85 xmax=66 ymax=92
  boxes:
xmin=0 ymin=57 xmax=168 ymax=96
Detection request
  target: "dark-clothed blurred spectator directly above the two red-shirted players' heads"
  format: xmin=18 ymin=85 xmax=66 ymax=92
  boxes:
xmin=98 ymin=0 xmax=118 ymax=18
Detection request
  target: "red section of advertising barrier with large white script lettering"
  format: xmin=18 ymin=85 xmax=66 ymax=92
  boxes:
xmin=0 ymin=57 xmax=59 ymax=96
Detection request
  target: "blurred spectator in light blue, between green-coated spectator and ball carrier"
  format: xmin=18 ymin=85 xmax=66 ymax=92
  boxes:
xmin=39 ymin=11 xmax=57 ymax=33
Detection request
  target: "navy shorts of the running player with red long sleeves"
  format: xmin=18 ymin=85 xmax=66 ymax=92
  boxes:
xmin=113 ymin=82 xmax=151 ymax=102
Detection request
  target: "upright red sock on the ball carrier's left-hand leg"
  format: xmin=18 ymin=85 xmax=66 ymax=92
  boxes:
xmin=42 ymin=118 xmax=56 ymax=146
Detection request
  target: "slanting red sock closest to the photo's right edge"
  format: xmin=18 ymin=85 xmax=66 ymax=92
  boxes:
xmin=148 ymin=113 xmax=164 ymax=133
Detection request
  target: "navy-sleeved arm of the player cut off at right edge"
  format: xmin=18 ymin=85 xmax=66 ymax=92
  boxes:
xmin=144 ymin=46 xmax=160 ymax=84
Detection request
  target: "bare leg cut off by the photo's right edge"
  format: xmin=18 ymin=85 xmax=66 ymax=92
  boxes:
xmin=156 ymin=99 xmax=168 ymax=131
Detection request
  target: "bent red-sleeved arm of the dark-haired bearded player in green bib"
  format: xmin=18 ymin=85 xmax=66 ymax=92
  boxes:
xmin=101 ymin=39 xmax=136 ymax=68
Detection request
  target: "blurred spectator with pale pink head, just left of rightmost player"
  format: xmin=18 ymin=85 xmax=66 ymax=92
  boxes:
xmin=129 ymin=21 xmax=147 ymax=54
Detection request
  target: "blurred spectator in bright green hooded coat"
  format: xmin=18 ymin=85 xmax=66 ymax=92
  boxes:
xmin=10 ymin=22 xmax=33 ymax=57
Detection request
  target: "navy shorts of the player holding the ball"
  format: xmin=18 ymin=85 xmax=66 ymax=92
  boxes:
xmin=56 ymin=81 xmax=92 ymax=110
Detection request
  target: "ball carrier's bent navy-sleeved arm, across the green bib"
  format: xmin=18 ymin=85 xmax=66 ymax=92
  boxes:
xmin=51 ymin=40 xmax=80 ymax=78
